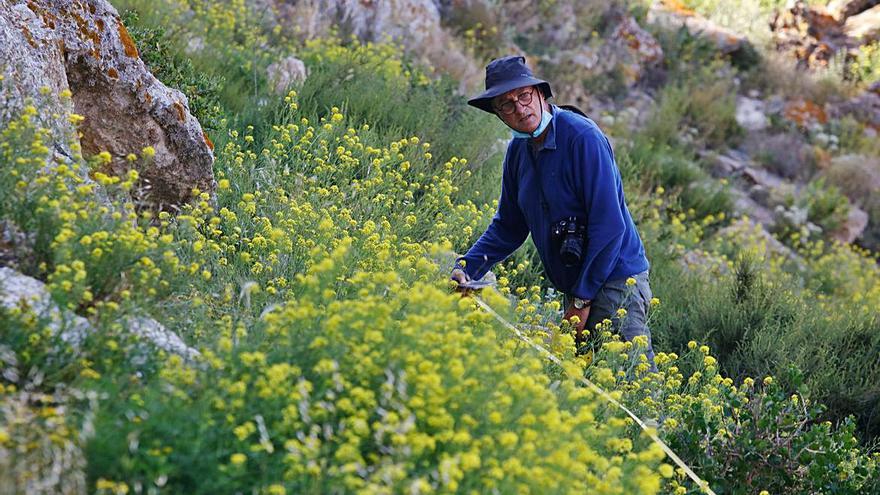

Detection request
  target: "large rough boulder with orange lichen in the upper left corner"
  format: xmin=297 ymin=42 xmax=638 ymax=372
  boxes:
xmin=0 ymin=0 xmax=214 ymax=208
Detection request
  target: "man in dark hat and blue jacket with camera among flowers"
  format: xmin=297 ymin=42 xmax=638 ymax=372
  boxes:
xmin=451 ymin=56 xmax=654 ymax=367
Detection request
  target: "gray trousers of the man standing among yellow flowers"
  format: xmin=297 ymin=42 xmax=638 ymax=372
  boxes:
xmin=565 ymin=271 xmax=656 ymax=370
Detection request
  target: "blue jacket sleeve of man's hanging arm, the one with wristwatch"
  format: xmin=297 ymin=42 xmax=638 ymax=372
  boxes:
xmin=572 ymin=128 xmax=626 ymax=299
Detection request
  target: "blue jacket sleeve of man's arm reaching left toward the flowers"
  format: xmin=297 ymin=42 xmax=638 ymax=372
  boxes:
xmin=458 ymin=148 xmax=529 ymax=280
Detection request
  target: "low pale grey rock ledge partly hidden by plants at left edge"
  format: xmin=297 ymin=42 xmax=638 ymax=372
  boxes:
xmin=0 ymin=267 xmax=200 ymax=364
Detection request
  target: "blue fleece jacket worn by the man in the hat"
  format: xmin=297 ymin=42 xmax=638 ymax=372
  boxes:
xmin=459 ymin=106 xmax=649 ymax=299
